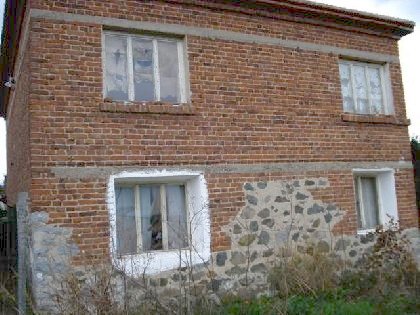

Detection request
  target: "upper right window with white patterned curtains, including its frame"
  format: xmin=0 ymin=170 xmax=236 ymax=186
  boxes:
xmin=339 ymin=60 xmax=393 ymax=115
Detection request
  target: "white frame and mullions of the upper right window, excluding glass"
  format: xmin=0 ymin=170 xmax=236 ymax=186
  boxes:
xmin=339 ymin=59 xmax=394 ymax=115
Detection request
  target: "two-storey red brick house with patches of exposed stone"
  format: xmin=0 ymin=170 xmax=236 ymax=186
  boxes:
xmin=0 ymin=0 xmax=417 ymax=308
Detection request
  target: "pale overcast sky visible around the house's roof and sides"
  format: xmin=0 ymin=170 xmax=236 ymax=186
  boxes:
xmin=0 ymin=0 xmax=420 ymax=182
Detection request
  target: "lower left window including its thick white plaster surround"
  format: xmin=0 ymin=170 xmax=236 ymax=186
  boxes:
xmin=108 ymin=170 xmax=210 ymax=275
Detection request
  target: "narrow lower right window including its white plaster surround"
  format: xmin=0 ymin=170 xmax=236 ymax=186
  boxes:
xmin=353 ymin=168 xmax=398 ymax=234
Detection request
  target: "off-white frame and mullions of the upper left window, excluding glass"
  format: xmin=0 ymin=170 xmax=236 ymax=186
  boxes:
xmin=102 ymin=30 xmax=188 ymax=105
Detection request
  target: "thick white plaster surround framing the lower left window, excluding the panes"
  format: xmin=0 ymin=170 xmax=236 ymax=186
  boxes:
xmin=107 ymin=170 xmax=210 ymax=276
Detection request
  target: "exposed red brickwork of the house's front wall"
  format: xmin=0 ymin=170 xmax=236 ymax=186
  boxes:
xmin=13 ymin=0 xmax=416 ymax=262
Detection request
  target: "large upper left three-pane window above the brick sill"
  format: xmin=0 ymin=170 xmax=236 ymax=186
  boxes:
xmin=103 ymin=31 xmax=187 ymax=104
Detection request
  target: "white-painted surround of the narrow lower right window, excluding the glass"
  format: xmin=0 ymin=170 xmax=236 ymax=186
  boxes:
xmin=353 ymin=168 xmax=398 ymax=234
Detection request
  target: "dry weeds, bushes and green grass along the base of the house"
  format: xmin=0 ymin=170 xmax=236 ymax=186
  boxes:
xmin=0 ymin=220 xmax=420 ymax=315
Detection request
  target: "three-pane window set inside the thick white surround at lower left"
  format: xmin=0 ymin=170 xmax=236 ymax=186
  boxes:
xmin=115 ymin=184 xmax=189 ymax=255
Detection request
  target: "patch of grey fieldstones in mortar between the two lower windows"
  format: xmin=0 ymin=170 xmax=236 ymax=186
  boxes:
xmin=215 ymin=178 xmax=388 ymax=300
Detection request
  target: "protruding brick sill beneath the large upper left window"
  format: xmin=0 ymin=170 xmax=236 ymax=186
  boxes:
xmin=99 ymin=100 xmax=194 ymax=115
